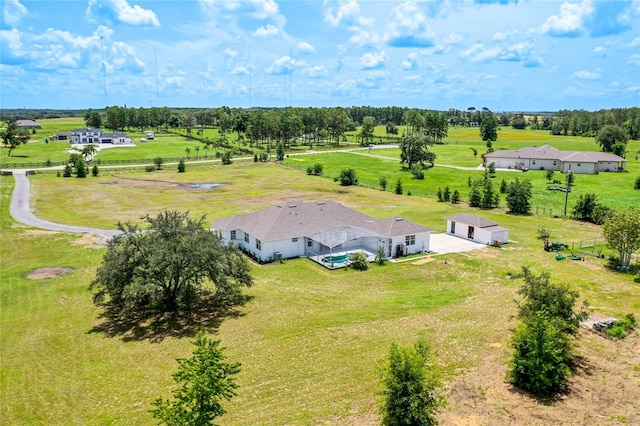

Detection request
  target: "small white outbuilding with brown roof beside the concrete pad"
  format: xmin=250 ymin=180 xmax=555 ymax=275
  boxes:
xmin=447 ymin=213 xmax=509 ymax=245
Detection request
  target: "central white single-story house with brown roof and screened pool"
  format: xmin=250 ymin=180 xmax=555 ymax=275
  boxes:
xmin=211 ymin=201 xmax=431 ymax=267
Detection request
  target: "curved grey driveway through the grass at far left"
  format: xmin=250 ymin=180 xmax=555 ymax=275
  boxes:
xmin=9 ymin=170 xmax=121 ymax=238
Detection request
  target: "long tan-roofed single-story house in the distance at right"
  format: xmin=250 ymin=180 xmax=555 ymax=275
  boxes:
xmin=484 ymin=145 xmax=627 ymax=174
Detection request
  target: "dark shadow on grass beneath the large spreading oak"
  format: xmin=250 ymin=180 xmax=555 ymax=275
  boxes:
xmin=88 ymin=295 xmax=252 ymax=343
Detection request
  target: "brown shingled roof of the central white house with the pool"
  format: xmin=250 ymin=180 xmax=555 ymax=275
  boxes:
xmin=211 ymin=201 xmax=430 ymax=241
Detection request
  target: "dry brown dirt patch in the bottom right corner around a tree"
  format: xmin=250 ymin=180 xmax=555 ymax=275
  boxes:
xmin=439 ymin=330 xmax=640 ymax=425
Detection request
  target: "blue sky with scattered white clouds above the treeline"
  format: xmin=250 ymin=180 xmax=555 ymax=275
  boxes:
xmin=0 ymin=0 xmax=640 ymax=111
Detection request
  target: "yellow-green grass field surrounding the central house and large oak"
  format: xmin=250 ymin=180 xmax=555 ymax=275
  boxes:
xmin=0 ymin=148 xmax=640 ymax=425
